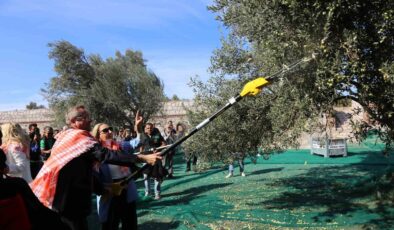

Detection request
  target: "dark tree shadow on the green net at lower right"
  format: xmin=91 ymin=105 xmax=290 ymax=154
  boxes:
xmin=248 ymin=151 xmax=394 ymax=229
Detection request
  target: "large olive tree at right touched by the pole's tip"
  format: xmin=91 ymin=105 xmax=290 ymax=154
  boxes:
xmin=185 ymin=0 xmax=394 ymax=161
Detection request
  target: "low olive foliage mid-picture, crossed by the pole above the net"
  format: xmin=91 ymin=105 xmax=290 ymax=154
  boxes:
xmin=184 ymin=63 xmax=317 ymax=162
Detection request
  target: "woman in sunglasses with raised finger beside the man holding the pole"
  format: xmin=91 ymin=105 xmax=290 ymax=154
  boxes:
xmin=92 ymin=113 xmax=142 ymax=230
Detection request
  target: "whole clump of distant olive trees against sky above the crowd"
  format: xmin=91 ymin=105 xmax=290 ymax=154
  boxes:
xmin=43 ymin=41 xmax=164 ymax=126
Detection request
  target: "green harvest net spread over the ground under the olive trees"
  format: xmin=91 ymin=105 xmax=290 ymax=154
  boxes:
xmin=88 ymin=139 xmax=394 ymax=229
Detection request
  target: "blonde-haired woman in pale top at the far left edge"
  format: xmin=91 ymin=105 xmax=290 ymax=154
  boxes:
xmin=1 ymin=123 xmax=32 ymax=183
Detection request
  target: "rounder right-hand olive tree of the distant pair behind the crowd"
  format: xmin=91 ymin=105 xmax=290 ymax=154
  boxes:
xmin=89 ymin=50 xmax=164 ymax=125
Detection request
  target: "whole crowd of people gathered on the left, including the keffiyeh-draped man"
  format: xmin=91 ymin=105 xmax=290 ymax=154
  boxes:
xmin=0 ymin=106 xmax=197 ymax=229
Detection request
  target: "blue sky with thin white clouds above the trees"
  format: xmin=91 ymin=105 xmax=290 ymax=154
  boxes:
xmin=0 ymin=0 xmax=224 ymax=111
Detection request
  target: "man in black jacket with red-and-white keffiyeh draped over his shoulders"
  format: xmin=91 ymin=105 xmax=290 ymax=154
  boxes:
xmin=30 ymin=106 xmax=161 ymax=230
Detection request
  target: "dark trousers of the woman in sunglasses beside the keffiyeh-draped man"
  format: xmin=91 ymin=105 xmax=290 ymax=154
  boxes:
xmin=101 ymin=189 xmax=138 ymax=230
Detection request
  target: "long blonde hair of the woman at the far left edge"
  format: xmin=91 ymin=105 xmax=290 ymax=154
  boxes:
xmin=1 ymin=122 xmax=30 ymax=149
